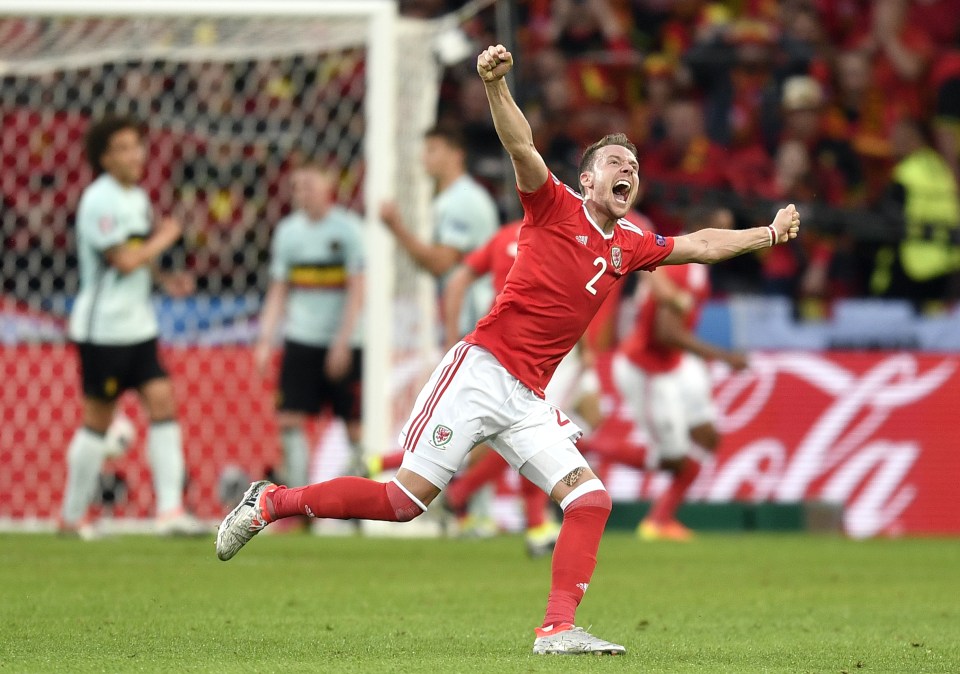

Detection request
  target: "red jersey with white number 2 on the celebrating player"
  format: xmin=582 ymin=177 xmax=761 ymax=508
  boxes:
xmin=464 ymin=174 xmax=673 ymax=398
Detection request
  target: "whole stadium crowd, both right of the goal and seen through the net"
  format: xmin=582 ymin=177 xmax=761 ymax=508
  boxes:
xmin=0 ymin=0 xmax=960 ymax=315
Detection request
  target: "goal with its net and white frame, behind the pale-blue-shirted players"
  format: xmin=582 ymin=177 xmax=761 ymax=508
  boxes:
xmin=0 ymin=0 xmax=440 ymax=526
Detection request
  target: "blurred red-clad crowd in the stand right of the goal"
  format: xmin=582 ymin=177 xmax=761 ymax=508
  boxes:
xmin=426 ymin=0 xmax=960 ymax=313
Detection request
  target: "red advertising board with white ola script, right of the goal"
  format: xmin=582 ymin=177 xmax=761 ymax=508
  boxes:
xmin=595 ymin=352 xmax=960 ymax=537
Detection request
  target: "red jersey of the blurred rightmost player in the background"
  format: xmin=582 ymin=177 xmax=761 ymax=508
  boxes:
xmin=620 ymin=264 xmax=710 ymax=374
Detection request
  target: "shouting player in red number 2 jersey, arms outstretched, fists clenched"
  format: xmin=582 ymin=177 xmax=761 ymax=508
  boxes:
xmin=217 ymin=45 xmax=800 ymax=654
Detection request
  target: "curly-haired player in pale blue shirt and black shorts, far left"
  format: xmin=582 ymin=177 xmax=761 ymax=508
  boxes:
xmin=60 ymin=118 xmax=204 ymax=536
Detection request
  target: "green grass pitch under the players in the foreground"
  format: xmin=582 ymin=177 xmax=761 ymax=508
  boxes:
xmin=0 ymin=534 xmax=960 ymax=674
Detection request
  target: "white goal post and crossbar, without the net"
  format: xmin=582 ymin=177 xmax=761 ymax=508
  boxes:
xmin=0 ymin=0 xmax=440 ymax=462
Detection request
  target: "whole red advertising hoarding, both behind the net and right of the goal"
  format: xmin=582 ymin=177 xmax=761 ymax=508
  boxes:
xmin=0 ymin=345 xmax=960 ymax=537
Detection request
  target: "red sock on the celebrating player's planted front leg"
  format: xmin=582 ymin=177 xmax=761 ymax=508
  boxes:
xmin=542 ymin=489 xmax=613 ymax=627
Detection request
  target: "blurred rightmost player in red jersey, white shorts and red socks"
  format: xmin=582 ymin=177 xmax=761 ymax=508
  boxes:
xmin=613 ymin=242 xmax=747 ymax=541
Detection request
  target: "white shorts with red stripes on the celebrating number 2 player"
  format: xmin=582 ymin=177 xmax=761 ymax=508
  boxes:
xmin=400 ymin=342 xmax=587 ymax=494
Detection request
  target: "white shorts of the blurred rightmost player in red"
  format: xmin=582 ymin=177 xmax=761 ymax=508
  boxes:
xmin=613 ymin=353 xmax=717 ymax=467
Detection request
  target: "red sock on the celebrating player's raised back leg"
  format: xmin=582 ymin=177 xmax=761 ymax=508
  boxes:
xmin=267 ymin=477 xmax=423 ymax=522
